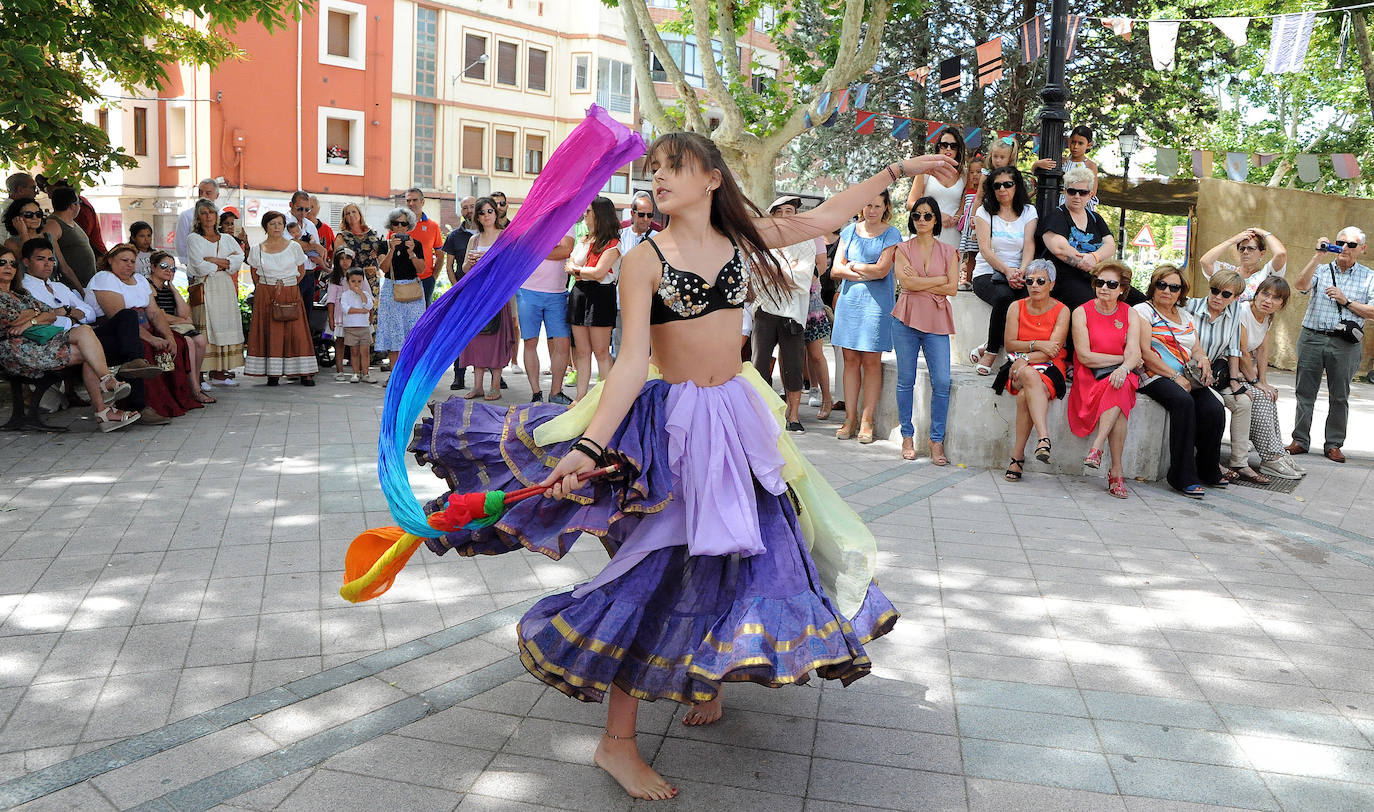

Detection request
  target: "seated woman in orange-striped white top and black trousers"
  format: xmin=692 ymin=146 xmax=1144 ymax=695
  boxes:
xmin=1135 ymin=265 xmax=1227 ymax=499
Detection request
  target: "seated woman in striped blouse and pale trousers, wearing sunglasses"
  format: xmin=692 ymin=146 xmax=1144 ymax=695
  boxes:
xmin=1186 ymin=269 xmax=1270 ymax=485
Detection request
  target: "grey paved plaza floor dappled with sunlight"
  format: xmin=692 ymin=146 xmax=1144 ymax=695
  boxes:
xmin=0 ymin=357 xmax=1374 ymax=812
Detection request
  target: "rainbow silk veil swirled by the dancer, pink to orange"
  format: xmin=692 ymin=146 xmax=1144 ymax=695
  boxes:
xmin=339 ymin=104 xmax=644 ymax=602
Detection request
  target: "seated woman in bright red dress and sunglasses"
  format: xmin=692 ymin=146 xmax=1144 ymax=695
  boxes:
xmin=1066 ymin=261 xmax=1143 ymax=499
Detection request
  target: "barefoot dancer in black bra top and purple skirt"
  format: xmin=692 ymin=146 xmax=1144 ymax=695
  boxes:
xmin=398 ymin=133 xmax=958 ymax=800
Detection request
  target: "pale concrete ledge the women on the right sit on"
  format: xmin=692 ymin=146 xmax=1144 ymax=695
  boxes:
xmin=831 ymin=351 xmax=1169 ymax=481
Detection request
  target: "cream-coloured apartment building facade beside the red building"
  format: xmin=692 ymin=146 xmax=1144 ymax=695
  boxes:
xmin=390 ymin=0 xmax=636 ymax=205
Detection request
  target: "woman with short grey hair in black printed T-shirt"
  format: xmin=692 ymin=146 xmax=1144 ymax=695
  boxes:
xmin=1040 ymin=166 xmax=1126 ymax=311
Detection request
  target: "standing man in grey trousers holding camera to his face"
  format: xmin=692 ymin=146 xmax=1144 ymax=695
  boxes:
xmin=1287 ymin=225 xmax=1374 ymax=463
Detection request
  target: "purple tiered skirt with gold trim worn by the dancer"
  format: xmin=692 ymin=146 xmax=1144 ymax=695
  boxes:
xmin=411 ymin=378 xmax=897 ymax=703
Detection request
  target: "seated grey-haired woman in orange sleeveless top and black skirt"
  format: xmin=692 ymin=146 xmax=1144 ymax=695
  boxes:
xmin=992 ymin=260 xmax=1069 ymax=482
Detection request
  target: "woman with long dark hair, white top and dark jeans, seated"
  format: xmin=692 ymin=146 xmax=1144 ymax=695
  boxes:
xmin=970 ymin=166 xmax=1039 ymax=375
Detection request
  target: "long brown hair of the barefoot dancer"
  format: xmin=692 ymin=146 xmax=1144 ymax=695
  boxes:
xmin=649 ymin=132 xmax=793 ymax=298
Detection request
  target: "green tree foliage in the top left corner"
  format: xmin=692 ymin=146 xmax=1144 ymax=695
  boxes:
xmin=0 ymin=0 xmax=297 ymax=179
